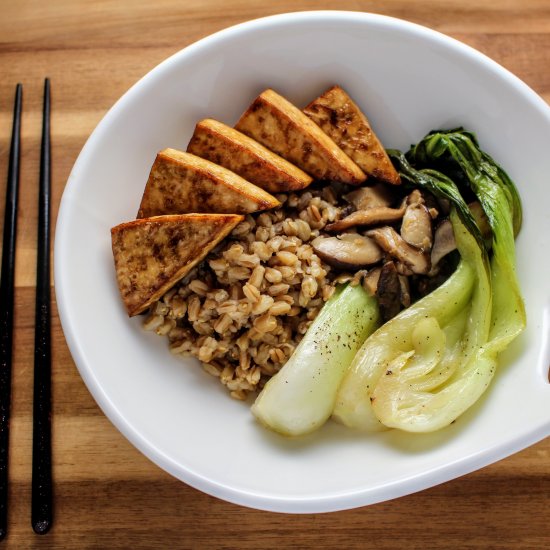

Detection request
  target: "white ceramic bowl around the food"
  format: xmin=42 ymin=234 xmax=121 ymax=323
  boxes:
xmin=55 ymin=12 xmax=550 ymax=512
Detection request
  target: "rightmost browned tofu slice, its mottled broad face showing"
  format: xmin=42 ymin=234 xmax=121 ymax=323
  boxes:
xmin=304 ymin=86 xmax=401 ymax=185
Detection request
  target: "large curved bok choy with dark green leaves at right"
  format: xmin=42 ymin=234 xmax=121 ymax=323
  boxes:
xmin=333 ymin=130 xmax=526 ymax=432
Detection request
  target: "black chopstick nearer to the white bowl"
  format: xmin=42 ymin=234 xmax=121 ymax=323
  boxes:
xmin=31 ymin=78 xmax=53 ymax=534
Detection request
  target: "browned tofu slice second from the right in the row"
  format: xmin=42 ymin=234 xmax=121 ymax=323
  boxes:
xmin=235 ymin=89 xmax=366 ymax=185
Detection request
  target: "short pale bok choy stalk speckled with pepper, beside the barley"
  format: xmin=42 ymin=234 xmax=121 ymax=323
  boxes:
xmin=252 ymin=285 xmax=379 ymax=436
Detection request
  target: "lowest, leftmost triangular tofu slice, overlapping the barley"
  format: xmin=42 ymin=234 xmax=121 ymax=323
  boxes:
xmin=111 ymin=214 xmax=244 ymax=317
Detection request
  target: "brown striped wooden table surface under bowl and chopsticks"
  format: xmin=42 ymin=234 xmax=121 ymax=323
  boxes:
xmin=0 ymin=0 xmax=550 ymax=550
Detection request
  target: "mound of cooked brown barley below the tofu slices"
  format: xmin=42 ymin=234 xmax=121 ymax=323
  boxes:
xmin=144 ymin=190 xmax=352 ymax=400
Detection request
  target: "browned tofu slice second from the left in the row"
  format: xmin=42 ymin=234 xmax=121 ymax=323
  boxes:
xmin=137 ymin=149 xmax=281 ymax=222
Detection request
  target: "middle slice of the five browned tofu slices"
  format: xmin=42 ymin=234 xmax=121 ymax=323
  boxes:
xmin=187 ymin=118 xmax=312 ymax=193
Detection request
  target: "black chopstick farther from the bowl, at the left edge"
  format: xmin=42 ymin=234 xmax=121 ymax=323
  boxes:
xmin=0 ymin=84 xmax=23 ymax=540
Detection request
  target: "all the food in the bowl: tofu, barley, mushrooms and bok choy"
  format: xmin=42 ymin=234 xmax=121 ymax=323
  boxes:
xmin=111 ymin=86 xmax=526 ymax=436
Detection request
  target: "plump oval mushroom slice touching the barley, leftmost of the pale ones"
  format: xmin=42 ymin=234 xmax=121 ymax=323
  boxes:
xmin=311 ymin=233 xmax=383 ymax=269
